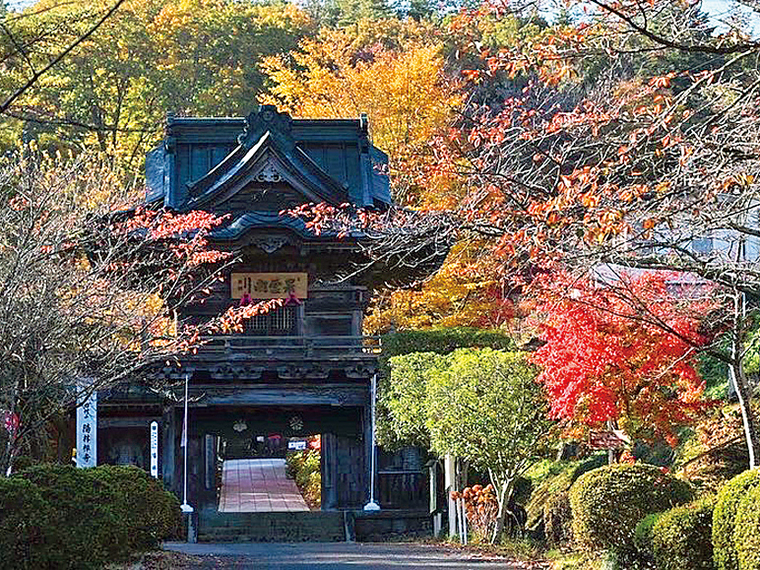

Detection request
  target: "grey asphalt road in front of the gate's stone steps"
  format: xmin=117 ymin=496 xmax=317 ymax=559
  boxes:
xmin=164 ymin=542 xmax=524 ymax=570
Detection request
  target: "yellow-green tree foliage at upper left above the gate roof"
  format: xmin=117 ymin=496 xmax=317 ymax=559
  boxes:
xmin=0 ymin=0 xmax=312 ymax=172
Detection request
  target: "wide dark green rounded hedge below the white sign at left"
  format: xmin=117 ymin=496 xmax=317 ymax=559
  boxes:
xmin=13 ymin=465 xmax=181 ymax=570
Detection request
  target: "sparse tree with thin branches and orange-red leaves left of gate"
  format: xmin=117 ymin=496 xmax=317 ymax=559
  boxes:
xmin=0 ymin=148 xmax=280 ymax=474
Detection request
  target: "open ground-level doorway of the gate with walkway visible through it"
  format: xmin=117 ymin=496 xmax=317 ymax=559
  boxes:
xmin=189 ymin=406 xmax=370 ymax=512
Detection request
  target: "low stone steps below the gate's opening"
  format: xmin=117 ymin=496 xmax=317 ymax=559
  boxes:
xmin=198 ymin=511 xmax=346 ymax=542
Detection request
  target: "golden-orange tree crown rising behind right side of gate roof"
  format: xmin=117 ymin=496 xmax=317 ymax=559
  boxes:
xmin=261 ymin=22 xmax=462 ymax=209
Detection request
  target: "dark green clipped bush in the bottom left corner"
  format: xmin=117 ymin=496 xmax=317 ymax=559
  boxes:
xmin=0 ymin=478 xmax=50 ymax=570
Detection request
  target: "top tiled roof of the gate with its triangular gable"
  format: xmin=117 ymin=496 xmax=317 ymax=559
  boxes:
xmin=146 ymin=105 xmax=391 ymax=214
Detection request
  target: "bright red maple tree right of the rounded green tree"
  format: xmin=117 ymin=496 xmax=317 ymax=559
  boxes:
xmin=533 ymin=273 xmax=711 ymax=445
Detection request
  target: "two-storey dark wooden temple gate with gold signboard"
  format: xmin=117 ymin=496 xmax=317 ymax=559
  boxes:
xmin=92 ymin=106 xmax=427 ymax=536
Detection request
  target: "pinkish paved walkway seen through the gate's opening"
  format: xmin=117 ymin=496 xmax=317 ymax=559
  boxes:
xmin=219 ymin=459 xmax=309 ymax=513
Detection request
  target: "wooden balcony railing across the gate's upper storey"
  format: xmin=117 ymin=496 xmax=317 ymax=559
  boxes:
xmin=198 ymin=335 xmax=381 ymax=358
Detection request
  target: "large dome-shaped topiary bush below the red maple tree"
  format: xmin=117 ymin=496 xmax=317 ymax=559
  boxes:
xmin=570 ymin=464 xmax=694 ymax=551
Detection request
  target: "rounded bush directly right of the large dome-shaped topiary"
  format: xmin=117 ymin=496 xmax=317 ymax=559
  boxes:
xmin=651 ymin=497 xmax=716 ymax=570
